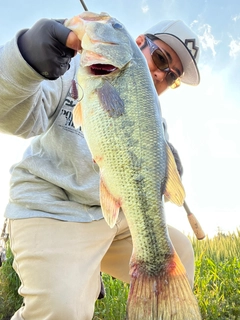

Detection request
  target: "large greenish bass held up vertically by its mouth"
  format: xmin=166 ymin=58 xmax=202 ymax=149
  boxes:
xmin=65 ymin=12 xmax=201 ymax=320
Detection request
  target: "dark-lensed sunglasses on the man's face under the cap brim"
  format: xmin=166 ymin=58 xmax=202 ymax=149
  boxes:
xmin=145 ymin=35 xmax=181 ymax=89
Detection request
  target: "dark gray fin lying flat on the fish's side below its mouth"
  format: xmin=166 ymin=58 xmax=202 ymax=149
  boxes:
xmin=97 ymin=81 xmax=124 ymax=118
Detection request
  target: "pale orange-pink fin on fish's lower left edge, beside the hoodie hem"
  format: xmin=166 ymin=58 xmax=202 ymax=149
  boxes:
xmin=100 ymin=179 xmax=120 ymax=228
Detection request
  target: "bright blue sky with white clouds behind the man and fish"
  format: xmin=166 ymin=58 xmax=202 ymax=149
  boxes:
xmin=0 ymin=0 xmax=240 ymax=236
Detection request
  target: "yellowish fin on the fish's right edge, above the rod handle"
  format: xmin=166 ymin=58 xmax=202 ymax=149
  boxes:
xmin=164 ymin=144 xmax=185 ymax=206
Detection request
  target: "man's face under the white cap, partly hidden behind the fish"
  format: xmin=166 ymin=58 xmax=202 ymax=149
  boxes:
xmin=136 ymin=35 xmax=183 ymax=95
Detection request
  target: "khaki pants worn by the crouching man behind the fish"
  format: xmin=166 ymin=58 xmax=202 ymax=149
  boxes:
xmin=9 ymin=213 xmax=194 ymax=320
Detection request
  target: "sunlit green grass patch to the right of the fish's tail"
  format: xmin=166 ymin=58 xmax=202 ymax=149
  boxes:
xmin=193 ymin=231 xmax=240 ymax=320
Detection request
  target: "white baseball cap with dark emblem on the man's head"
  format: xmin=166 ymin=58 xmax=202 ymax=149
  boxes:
xmin=145 ymin=20 xmax=200 ymax=86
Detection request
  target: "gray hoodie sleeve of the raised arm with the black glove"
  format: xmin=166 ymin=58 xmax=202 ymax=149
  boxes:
xmin=0 ymin=31 xmax=74 ymax=138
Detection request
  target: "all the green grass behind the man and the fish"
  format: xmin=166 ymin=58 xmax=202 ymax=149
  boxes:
xmin=0 ymin=230 xmax=240 ymax=320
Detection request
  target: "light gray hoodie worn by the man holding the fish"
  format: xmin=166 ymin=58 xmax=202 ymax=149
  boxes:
xmin=0 ymin=32 xmax=102 ymax=222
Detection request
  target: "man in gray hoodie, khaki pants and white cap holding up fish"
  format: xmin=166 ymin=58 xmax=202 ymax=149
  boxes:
xmin=0 ymin=13 xmax=199 ymax=320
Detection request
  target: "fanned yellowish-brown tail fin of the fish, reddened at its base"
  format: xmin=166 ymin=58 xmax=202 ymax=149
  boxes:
xmin=127 ymin=253 xmax=201 ymax=320
